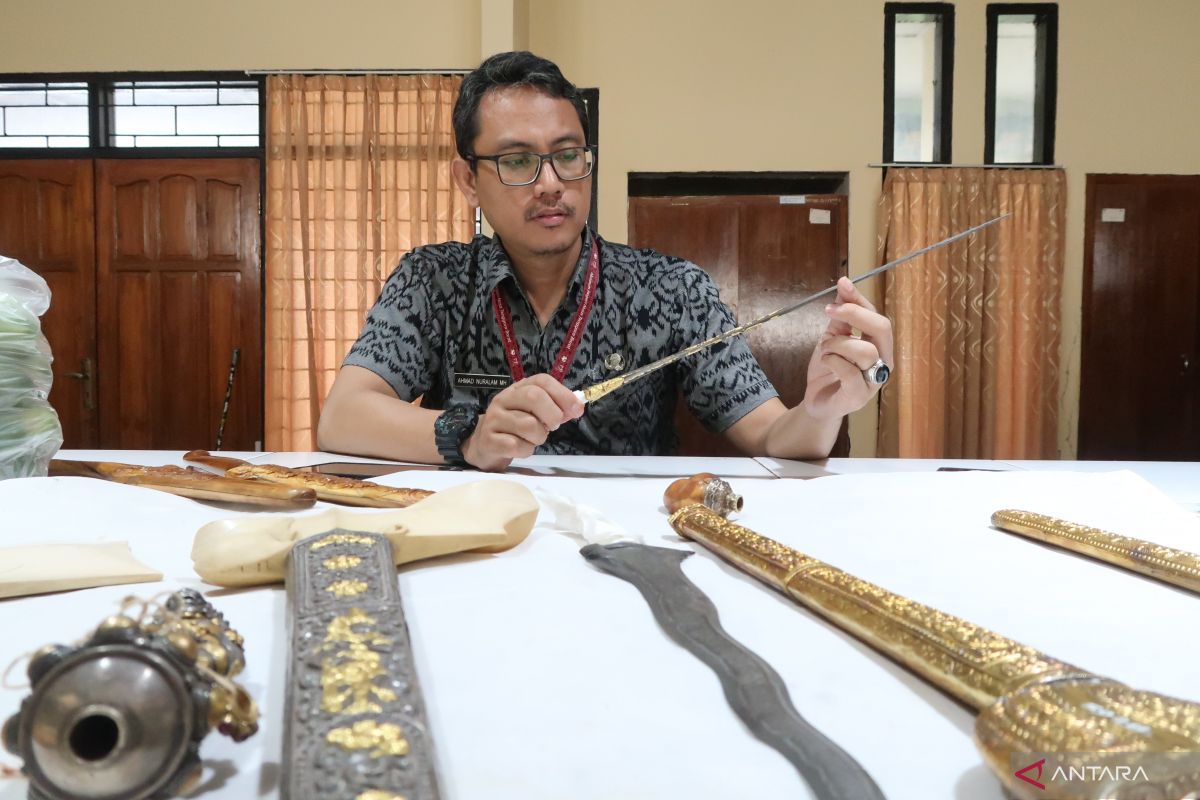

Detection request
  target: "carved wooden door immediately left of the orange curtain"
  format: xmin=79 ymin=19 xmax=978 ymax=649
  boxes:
xmin=96 ymin=158 xmax=262 ymax=450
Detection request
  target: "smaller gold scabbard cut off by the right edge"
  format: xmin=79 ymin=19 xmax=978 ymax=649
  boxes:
xmin=991 ymin=509 xmax=1200 ymax=594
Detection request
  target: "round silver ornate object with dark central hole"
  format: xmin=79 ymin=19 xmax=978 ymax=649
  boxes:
xmin=4 ymin=589 xmax=258 ymax=800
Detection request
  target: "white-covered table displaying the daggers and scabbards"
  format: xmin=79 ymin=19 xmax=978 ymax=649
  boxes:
xmin=0 ymin=452 xmax=1200 ymax=800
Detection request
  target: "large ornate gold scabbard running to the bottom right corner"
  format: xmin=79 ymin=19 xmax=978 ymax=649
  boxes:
xmin=671 ymin=505 xmax=1200 ymax=800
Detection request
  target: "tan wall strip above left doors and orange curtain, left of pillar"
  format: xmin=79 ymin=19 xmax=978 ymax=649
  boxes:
xmin=0 ymin=0 xmax=480 ymax=72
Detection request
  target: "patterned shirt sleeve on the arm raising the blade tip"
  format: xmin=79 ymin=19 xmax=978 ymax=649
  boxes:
xmin=679 ymin=264 xmax=779 ymax=433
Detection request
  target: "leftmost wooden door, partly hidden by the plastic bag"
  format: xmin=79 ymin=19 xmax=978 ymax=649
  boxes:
xmin=0 ymin=158 xmax=100 ymax=447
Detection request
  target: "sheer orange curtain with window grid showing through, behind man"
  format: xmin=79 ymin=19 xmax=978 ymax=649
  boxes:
xmin=265 ymin=76 xmax=475 ymax=450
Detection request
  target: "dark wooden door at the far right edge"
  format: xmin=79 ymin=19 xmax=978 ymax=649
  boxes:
xmin=1079 ymin=175 xmax=1200 ymax=461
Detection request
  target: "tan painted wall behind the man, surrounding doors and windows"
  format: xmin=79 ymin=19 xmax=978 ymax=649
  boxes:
xmin=0 ymin=0 xmax=1200 ymax=457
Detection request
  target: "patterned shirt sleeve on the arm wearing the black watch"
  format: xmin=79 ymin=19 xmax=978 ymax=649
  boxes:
xmin=342 ymin=251 xmax=442 ymax=401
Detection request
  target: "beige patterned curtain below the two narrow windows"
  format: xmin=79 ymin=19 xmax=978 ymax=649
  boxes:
xmin=877 ymin=168 xmax=1067 ymax=458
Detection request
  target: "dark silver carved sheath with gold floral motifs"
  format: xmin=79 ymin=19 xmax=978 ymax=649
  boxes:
xmin=282 ymin=530 xmax=439 ymax=800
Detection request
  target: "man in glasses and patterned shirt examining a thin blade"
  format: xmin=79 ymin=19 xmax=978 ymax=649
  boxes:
xmin=318 ymin=53 xmax=892 ymax=470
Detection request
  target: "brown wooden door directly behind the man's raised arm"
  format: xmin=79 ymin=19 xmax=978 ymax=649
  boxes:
xmin=629 ymin=194 xmax=850 ymax=456
